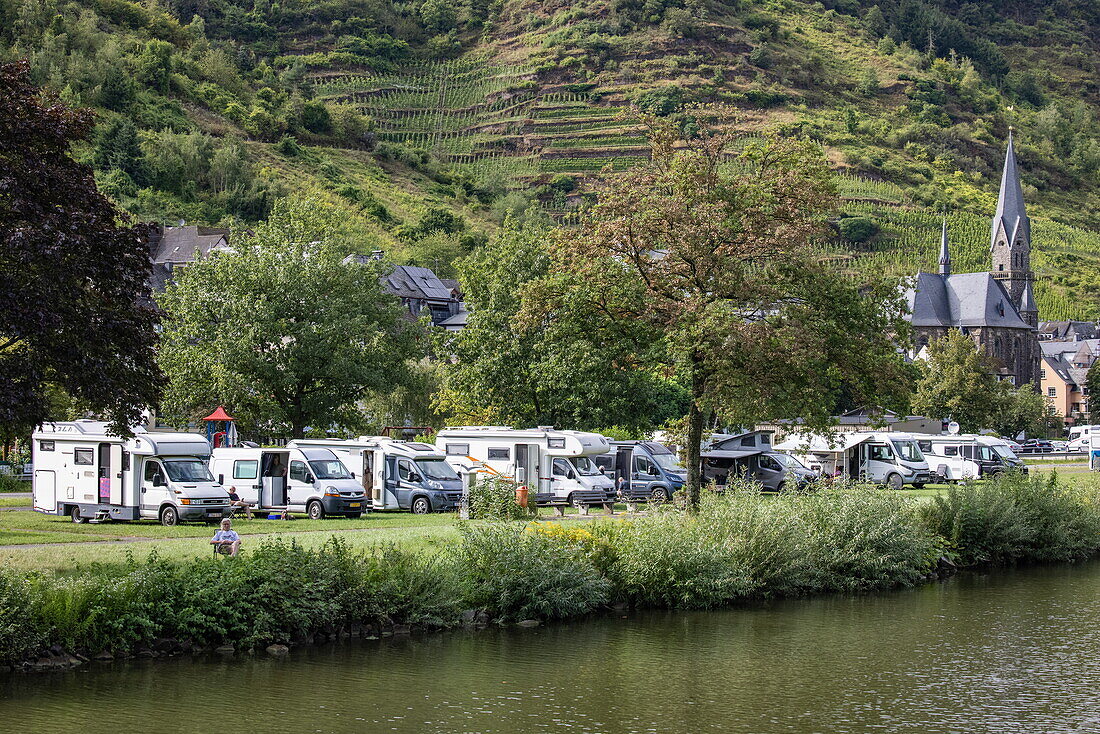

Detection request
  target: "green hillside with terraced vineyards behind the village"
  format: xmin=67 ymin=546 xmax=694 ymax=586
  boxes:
xmin=0 ymin=0 xmax=1100 ymax=318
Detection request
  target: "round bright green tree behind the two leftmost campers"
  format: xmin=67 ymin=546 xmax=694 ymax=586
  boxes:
xmin=161 ymin=197 xmax=419 ymax=438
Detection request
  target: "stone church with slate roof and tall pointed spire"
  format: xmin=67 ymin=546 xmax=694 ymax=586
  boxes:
xmin=906 ymin=130 xmax=1041 ymax=387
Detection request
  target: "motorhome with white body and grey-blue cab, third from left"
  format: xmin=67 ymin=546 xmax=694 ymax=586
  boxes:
xmin=288 ymin=436 xmax=462 ymax=515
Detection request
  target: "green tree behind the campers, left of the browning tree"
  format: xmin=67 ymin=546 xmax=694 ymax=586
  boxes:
xmin=437 ymin=219 xmax=683 ymax=431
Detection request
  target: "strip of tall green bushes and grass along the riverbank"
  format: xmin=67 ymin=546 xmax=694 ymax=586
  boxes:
xmin=0 ymin=475 xmax=1100 ymax=673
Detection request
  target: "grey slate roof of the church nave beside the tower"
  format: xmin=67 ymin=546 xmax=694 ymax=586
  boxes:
xmin=905 ymin=273 xmax=1031 ymax=330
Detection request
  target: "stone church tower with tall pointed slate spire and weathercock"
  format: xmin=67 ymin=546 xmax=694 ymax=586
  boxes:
xmin=989 ymin=128 xmax=1038 ymax=328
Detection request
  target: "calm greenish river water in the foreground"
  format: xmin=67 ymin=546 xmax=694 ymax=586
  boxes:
xmin=0 ymin=563 xmax=1100 ymax=734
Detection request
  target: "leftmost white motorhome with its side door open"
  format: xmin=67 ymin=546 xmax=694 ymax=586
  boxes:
xmin=32 ymin=420 xmax=229 ymax=525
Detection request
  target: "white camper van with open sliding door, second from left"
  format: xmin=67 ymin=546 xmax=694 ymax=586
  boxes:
xmin=210 ymin=446 xmax=367 ymax=519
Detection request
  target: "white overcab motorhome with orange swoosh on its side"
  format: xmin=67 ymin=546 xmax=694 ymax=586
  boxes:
xmin=436 ymin=426 xmax=615 ymax=505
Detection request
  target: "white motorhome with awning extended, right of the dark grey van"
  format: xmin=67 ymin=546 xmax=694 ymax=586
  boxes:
xmin=776 ymin=431 xmax=932 ymax=490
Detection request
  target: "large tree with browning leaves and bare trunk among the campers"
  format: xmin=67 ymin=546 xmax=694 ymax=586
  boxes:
xmin=541 ymin=120 xmax=904 ymax=507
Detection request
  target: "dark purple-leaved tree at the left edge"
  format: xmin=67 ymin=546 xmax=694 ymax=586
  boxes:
xmin=0 ymin=63 xmax=162 ymax=432
